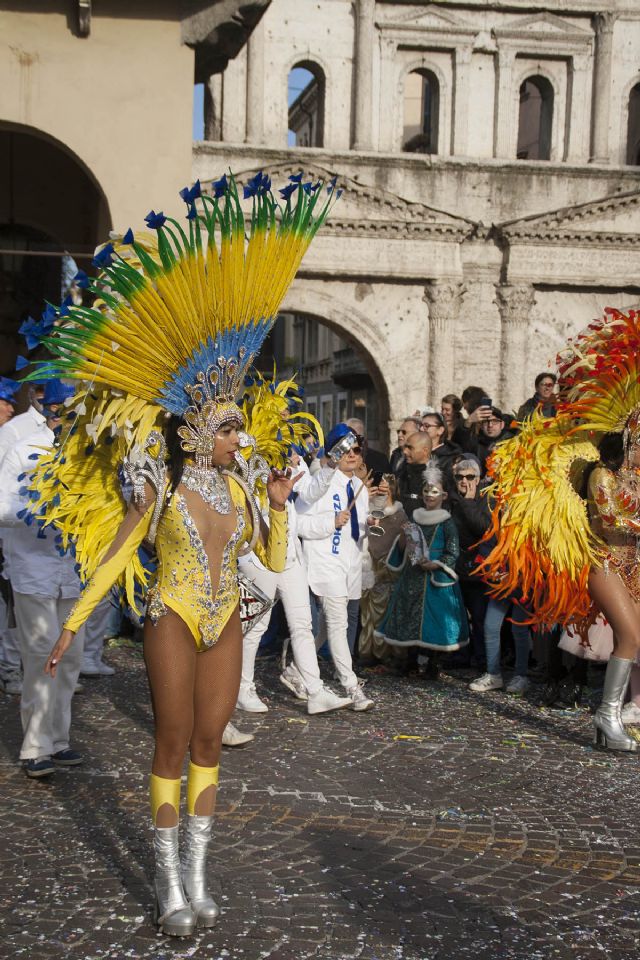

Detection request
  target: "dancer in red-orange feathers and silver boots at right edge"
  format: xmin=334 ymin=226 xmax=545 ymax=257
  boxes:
xmin=482 ymin=309 xmax=640 ymax=752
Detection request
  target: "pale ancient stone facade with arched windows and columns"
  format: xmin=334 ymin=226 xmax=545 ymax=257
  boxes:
xmin=193 ymin=0 xmax=640 ymax=442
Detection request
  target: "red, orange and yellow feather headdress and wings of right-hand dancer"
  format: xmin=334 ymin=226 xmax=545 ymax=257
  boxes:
xmin=479 ymin=308 xmax=640 ymax=624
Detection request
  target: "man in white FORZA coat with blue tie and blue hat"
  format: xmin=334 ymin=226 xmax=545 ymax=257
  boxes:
xmin=296 ymin=423 xmax=373 ymax=710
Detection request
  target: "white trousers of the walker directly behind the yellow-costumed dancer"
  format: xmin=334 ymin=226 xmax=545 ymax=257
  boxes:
xmin=242 ymin=560 xmax=322 ymax=695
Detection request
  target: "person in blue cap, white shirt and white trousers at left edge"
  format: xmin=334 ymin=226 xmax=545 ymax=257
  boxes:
xmin=0 ymin=380 xmax=83 ymax=778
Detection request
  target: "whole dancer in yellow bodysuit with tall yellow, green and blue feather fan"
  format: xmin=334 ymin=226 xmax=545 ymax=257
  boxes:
xmin=21 ymin=174 xmax=339 ymax=936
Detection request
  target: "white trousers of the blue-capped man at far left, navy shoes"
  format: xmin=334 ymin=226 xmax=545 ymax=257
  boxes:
xmin=13 ymin=591 xmax=83 ymax=760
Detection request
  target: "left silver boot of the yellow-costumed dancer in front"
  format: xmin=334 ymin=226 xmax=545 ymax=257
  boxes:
xmin=153 ymin=826 xmax=196 ymax=937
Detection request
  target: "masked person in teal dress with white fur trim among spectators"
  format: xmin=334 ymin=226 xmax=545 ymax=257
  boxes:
xmin=376 ymin=465 xmax=469 ymax=653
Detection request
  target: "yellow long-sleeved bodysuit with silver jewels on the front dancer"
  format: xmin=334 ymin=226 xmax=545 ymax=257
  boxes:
xmin=65 ymin=476 xmax=287 ymax=650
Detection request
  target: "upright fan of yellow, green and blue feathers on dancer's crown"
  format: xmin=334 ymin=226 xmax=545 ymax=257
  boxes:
xmin=24 ymin=173 xmax=340 ymax=442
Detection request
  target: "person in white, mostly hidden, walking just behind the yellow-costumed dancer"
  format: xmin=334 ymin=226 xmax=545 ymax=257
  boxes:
xmin=238 ymin=455 xmax=351 ymax=714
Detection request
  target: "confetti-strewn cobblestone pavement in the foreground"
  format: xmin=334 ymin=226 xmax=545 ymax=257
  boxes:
xmin=0 ymin=650 xmax=640 ymax=960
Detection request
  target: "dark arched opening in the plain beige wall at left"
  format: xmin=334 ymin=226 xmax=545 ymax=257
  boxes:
xmin=0 ymin=121 xmax=111 ymax=374
